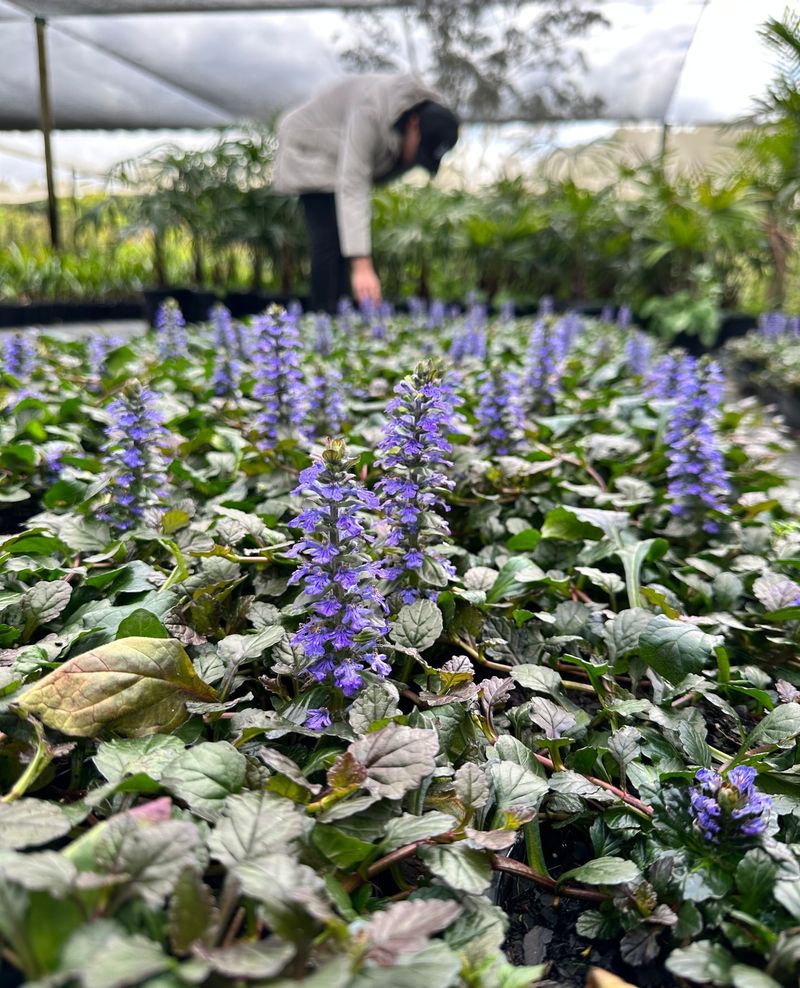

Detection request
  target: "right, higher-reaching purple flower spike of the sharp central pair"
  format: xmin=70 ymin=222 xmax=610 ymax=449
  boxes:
xmin=377 ymin=361 xmax=460 ymax=603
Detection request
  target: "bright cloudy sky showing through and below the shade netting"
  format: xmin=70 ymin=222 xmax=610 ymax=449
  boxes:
xmin=0 ymin=0 xmax=786 ymax=198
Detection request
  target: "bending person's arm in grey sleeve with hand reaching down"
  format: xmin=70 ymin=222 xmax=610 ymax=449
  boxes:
xmin=335 ymin=105 xmax=381 ymax=302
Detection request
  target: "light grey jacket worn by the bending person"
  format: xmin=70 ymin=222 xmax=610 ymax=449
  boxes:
xmin=272 ymin=75 xmax=442 ymax=257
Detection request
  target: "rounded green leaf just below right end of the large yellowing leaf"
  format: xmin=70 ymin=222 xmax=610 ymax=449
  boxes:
xmin=161 ymin=741 xmax=247 ymax=822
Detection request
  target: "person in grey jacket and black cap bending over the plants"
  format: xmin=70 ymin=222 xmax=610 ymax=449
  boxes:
xmin=273 ymin=74 xmax=458 ymax=312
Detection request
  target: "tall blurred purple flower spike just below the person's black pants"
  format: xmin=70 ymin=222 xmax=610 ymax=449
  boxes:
xmin=253 ymin=308 xmax=306 ymax=450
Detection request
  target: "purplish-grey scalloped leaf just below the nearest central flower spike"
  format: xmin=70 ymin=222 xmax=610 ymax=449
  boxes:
xmin=348 ymin=723 xmax=439 ymax=799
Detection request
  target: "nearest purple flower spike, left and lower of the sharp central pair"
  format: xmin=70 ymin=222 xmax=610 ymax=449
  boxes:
xmin=287 ymin=439 xmax=389 ymax=704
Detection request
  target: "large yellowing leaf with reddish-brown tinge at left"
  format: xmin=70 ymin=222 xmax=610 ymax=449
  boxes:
xmin=17 ymin=638 xmax=216 ymax=737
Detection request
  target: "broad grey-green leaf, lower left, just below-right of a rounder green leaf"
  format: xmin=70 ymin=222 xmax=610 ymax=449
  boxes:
xmin=208 ymin=792 xmax=307 ymax=868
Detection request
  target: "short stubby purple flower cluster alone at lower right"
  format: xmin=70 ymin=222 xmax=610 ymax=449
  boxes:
xmin=689 ymin=765 xmax=772 ymax=844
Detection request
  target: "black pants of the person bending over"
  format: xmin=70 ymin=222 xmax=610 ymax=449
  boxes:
xmin=300 ymin=192 xmax=350 ymax=313
